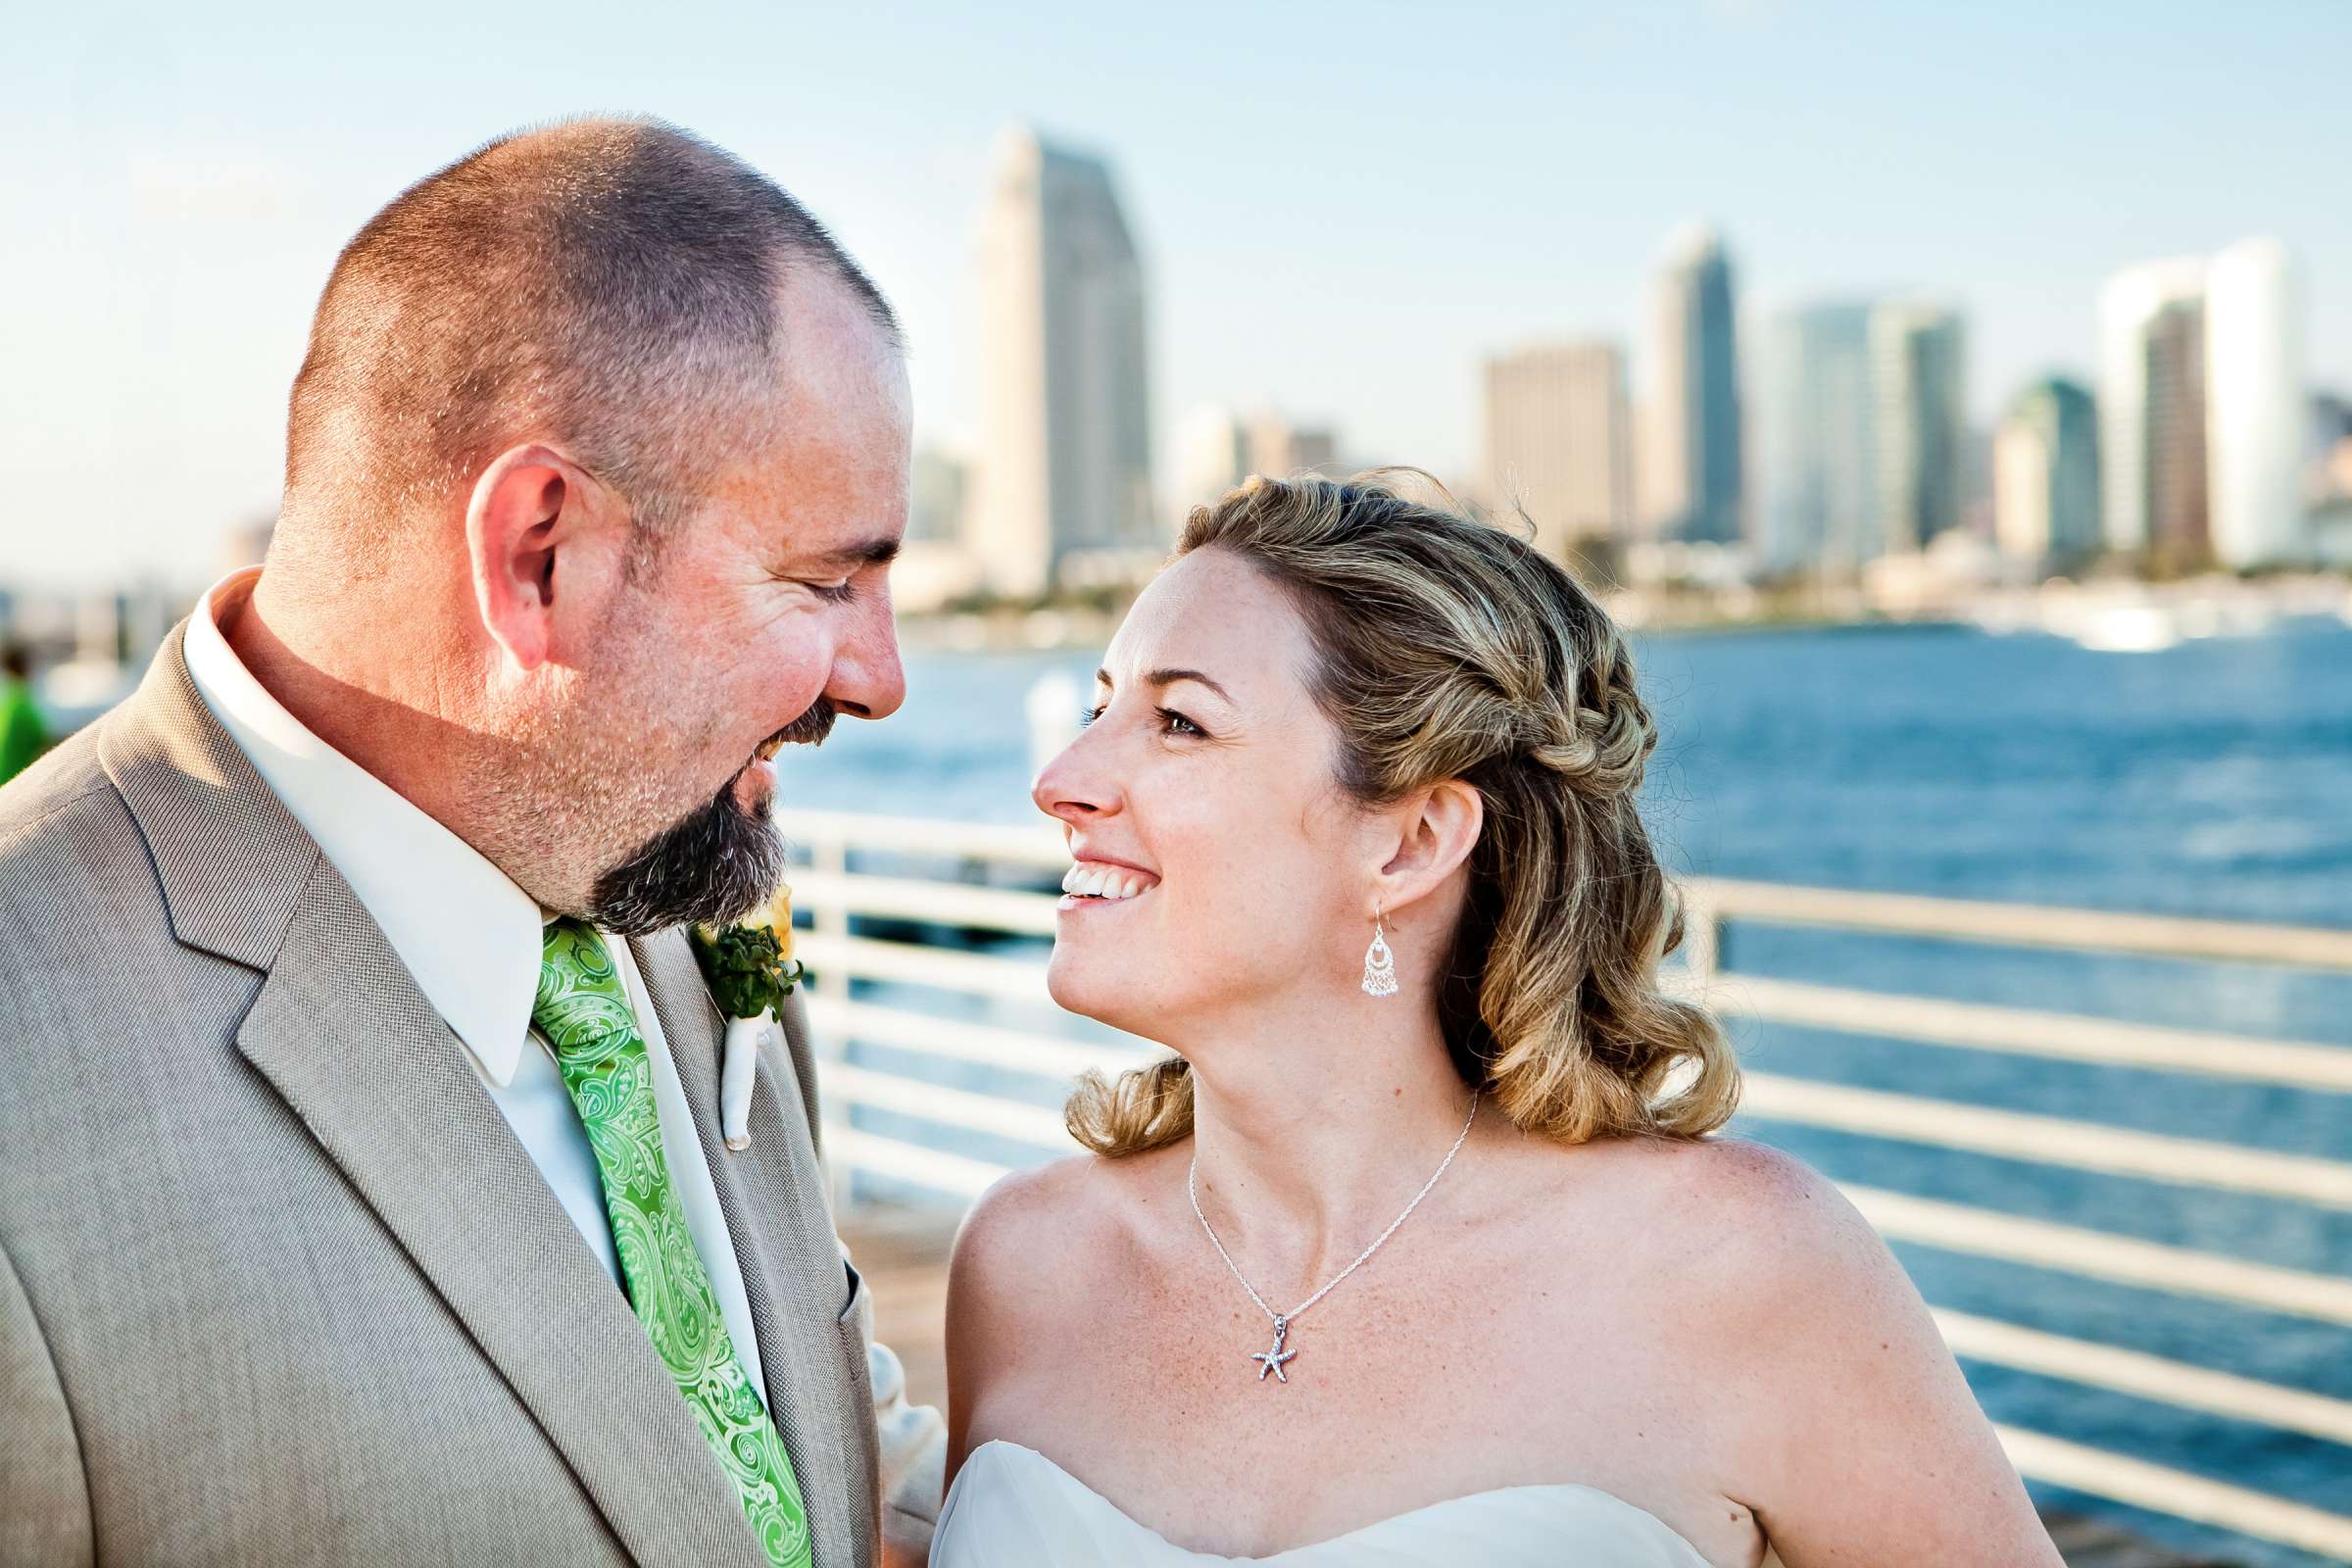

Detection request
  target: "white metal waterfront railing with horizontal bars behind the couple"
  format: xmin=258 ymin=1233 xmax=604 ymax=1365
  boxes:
xmin=783 ymin=813 xmax=2352 ymax=1561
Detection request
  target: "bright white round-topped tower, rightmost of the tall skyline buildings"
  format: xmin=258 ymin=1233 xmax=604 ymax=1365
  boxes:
xmin=2204 ymin=240 xmax=2310 ymax=566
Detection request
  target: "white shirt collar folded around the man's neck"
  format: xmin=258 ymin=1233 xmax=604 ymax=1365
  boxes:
xmin=188 ymin=566 xmax=543 ymax=1089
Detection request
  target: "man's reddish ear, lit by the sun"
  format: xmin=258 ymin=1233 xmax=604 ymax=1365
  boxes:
xmin=466 ymin=442 xmax=625 ymax=672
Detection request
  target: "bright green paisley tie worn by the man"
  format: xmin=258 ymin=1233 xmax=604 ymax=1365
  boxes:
xmin=531 ymin=919 xmax=811 ymax=1568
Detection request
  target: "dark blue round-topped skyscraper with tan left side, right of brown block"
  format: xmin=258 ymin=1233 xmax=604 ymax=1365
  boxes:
xmin=1635 ymin=225 xmax=1742 ymax=543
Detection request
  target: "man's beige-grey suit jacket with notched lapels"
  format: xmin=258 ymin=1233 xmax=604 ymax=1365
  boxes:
xmin=0 ymin=632 xmax=936 ymax=1568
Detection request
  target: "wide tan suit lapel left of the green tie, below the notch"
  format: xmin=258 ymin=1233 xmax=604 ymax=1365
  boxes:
xmin=237 ymin=860 xmax=762 ymax=1568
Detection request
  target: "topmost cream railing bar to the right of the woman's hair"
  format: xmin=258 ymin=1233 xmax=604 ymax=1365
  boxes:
xmin=1684 ymin=877 xmax=2352 ymax=971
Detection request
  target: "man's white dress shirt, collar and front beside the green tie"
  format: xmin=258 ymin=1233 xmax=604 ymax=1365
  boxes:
xmin=188 ymin=566 xmax=771 ymax=1403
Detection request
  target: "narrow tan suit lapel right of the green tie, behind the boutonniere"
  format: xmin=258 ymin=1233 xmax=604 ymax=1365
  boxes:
xmin=630 ymin=931 xmax=877 ymax=1566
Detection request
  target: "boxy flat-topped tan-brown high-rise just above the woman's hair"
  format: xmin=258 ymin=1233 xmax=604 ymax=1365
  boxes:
xmin=1484 ymin=343 xmax=1633 ymax=560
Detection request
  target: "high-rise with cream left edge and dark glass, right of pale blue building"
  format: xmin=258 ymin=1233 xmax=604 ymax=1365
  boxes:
xmin=1870 ymin=301 xmax=1969 ymax=555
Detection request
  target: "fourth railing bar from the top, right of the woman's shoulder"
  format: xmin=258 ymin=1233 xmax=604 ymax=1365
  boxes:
xmin=1839 ymin=1183 xmax=2352 ymax=1328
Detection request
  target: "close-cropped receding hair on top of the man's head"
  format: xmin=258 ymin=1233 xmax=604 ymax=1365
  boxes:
xmin=280 ymin=120 xmax=899 ymax=571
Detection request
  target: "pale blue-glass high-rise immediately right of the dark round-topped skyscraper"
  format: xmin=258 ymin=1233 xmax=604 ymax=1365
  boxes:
xmin=1757 ymin=303 xmax=1884 ymax=571
